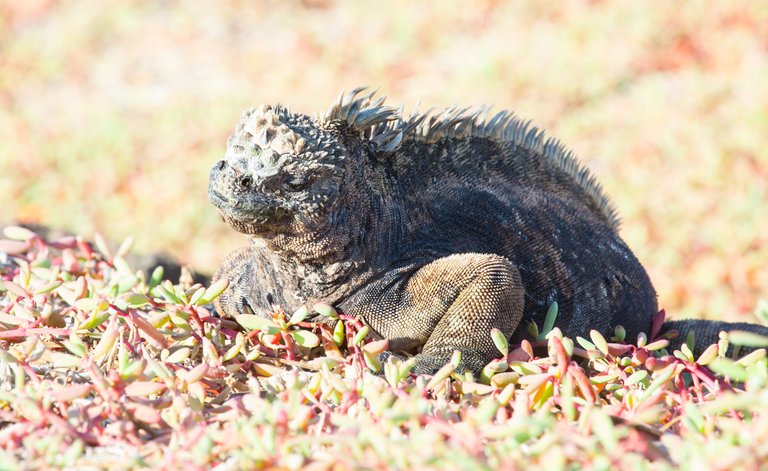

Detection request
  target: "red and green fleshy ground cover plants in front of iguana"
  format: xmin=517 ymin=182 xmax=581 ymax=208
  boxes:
xmin=0 ymin=227 xmax=768 ymax=469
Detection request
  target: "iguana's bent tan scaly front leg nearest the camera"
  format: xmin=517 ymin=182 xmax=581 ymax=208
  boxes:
xmin=354 ymin=253 xmax=524 ymax=373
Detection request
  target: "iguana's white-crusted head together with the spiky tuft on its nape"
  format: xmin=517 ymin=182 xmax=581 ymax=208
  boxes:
xmin=208 ymin=89 xmax=402 ymax=240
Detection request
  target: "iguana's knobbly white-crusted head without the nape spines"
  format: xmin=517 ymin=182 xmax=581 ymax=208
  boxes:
xmin=208 ymin=106 xmax=347 ymax=235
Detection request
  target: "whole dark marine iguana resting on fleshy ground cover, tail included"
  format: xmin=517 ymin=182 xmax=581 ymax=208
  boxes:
xmin=208 ymin=89 xmax=767 ymax=373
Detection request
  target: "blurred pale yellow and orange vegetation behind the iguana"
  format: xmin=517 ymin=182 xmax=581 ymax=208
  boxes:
xmin=0 ymin=0 xmax=768 ymax=320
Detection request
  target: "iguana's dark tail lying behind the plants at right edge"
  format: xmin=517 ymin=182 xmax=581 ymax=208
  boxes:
xmin=659 ymin=319 xmax=768 ymax=356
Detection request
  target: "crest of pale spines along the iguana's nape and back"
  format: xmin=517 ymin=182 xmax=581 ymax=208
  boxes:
xmin=319 ymin=87 xmax=619 ymax=229
